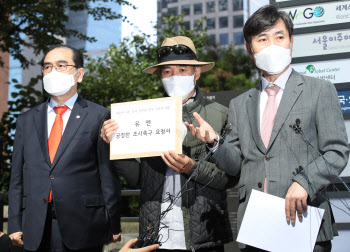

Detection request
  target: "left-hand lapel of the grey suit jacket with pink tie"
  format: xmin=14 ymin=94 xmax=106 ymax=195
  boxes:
xmin=247 ymin=83 xmax=266 ymax=153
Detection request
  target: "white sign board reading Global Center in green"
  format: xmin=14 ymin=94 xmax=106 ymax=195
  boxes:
xmin=292 ymin=59 xmax=350 ymax=84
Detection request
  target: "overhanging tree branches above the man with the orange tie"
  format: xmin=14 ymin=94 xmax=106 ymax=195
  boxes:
xmin=0 ymin=0 xmax=135 ymax=68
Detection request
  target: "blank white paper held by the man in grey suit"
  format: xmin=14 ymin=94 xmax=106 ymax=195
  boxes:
xmin=237 ymin=190 xmax=324 ymax=252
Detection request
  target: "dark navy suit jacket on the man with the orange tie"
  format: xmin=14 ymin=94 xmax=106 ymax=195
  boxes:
xmin=8 ymin=96 xmax=120 ymax=250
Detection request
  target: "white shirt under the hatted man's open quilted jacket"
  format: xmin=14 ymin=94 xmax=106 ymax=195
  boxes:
xmin=159 ymin=92 xmax=196 ymax=250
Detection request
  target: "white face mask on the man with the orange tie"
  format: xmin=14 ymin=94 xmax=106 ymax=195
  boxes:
xmin=43 ymin=69 xmax=78 ymax=96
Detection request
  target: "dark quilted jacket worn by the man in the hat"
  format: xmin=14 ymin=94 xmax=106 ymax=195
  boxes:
xmin=114 ymin=87 xmax=233 ymax=250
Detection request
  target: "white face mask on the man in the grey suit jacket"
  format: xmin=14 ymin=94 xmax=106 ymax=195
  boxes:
xmin=254 ymin=45 xmax=292 ymax=74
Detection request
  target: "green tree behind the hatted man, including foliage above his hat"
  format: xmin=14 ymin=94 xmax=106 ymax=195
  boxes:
xmin=79 ymin=15 xmax=207 ymax=108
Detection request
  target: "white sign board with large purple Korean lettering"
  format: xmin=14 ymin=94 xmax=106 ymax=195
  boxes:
xmin=293 ymin=29 xmax=350 ymax=58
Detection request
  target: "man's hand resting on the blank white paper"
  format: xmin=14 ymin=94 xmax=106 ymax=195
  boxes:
xmin=285 ymin=182 xmax=308 ymax=224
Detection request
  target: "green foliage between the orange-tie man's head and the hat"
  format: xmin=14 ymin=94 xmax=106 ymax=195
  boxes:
xmin=78 ymin=36 xmax=162 ymax=108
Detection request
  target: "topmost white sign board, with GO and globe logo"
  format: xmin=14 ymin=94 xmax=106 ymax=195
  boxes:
xmin=281 ymin=1 xmax=350 ymax=29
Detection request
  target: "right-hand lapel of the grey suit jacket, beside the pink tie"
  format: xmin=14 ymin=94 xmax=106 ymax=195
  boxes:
xmin=267 ymin=70 xmax=303 ymax=149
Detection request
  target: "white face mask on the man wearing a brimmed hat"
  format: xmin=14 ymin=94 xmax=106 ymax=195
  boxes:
xmin=162 ymin=74 xmax=194 ymax=100
